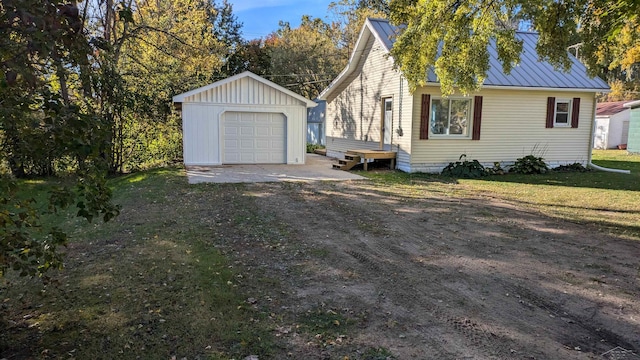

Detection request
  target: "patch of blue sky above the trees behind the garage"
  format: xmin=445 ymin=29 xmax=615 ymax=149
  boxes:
xmin=229 ymin=0 xmax=334 ymax=39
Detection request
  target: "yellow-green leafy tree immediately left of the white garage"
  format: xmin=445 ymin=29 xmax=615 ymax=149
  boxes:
xmin=89 ymin=0 xmax=226 ymax=173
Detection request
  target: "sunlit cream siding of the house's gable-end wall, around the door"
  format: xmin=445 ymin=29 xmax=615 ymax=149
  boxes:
xmin=326 ymin=36 xmax=412 ymax=168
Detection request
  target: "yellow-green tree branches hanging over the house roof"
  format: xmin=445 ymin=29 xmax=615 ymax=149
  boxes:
xmin=390 ymin=0 xmax=640 ymax=94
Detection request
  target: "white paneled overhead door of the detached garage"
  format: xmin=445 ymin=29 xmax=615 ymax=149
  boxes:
xmin=222 ymin=112 xmax=287 ymax=164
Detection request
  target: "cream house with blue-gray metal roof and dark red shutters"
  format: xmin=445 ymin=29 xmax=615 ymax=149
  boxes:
xmin=320 ymin=19 xmax=609 ymax=172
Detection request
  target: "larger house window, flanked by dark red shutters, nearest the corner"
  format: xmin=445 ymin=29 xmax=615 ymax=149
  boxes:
xmin=430 ymin=98 xmax=471 ymax=137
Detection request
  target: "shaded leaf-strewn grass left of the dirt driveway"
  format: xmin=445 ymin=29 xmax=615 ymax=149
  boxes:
xmin=0 ymin=169 xmax=277 ymax=359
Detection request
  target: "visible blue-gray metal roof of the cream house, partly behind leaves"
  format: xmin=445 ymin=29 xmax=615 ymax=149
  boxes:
xmin=369 ymin=19 xmax=609 ymax=90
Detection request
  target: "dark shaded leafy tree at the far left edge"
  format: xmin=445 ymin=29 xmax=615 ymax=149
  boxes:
xmin=0 ymin=0 xmax=118 ymax=276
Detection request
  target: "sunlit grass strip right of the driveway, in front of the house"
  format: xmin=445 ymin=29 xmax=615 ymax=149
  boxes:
xmin=360 ymin=150 xmax=640 ymax=239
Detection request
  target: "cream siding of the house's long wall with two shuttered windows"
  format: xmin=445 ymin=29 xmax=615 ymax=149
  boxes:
xmin=407 ymin=86 xmax=594 ymax=172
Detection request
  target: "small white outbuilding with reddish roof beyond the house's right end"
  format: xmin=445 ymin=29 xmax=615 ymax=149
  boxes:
xmin=593 ymin=101 xmax=631 ymax=149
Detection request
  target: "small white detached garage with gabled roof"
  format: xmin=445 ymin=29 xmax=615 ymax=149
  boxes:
xmin=173 ymin=71 xmax=317 ymax=166
